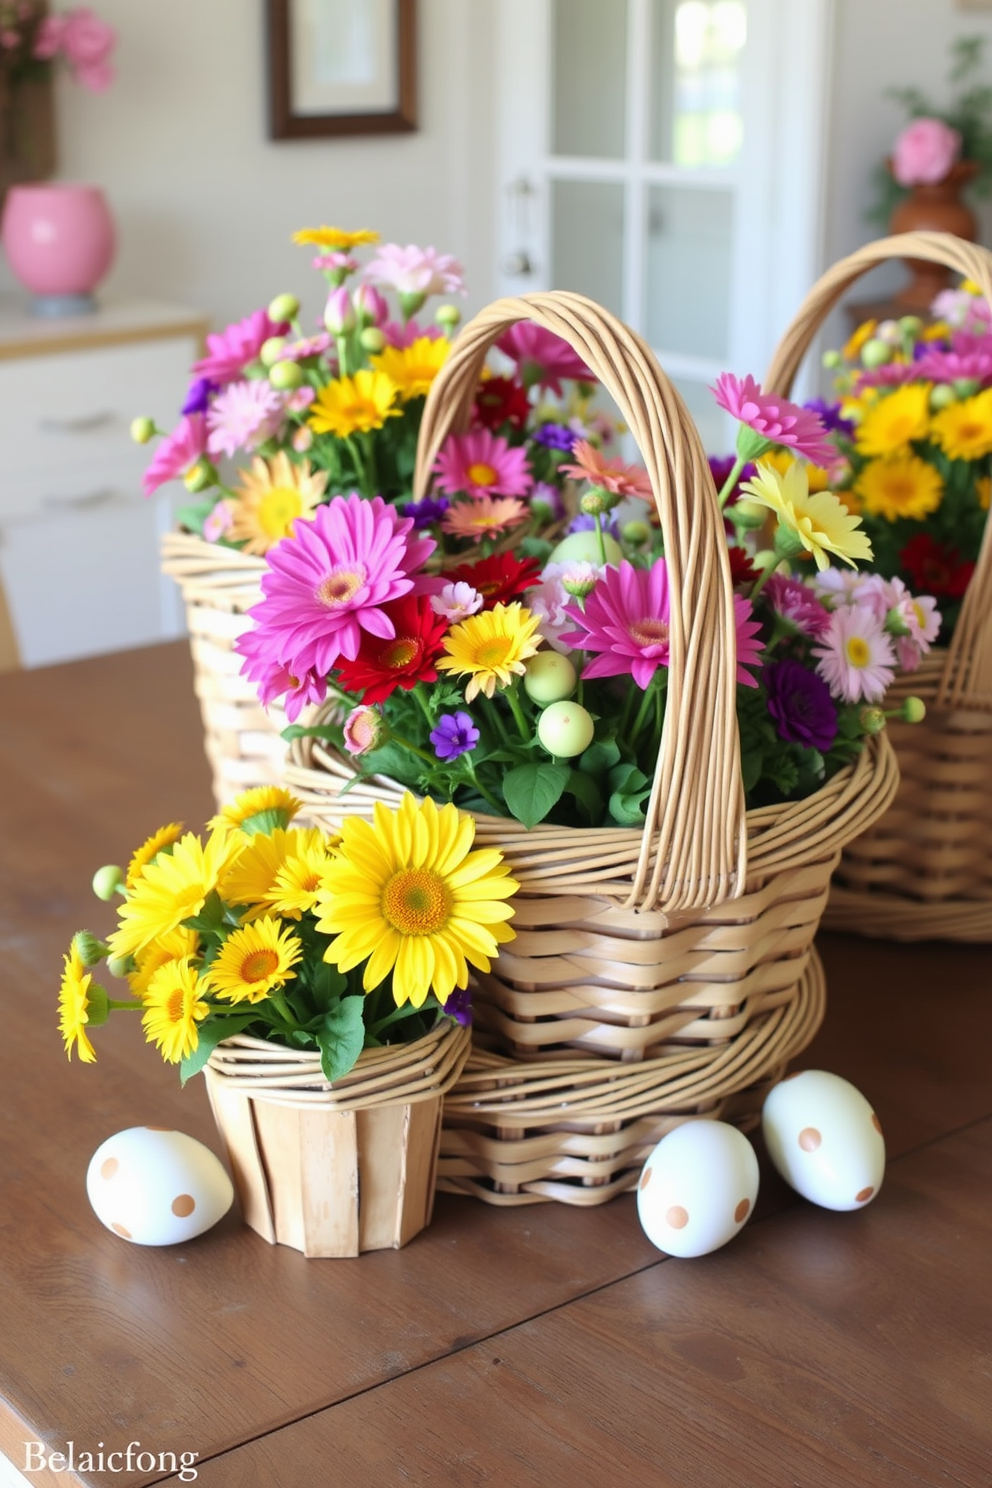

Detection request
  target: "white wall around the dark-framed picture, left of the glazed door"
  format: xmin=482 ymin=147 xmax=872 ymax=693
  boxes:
xmin=1 ymin=0 xmax=494 ymax=334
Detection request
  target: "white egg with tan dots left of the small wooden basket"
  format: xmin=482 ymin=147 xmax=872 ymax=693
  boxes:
xmin=86 ymin=1126 xmax=233 ymax=1245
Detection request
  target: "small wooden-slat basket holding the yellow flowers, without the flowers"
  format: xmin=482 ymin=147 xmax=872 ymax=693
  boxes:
xmin=204 ymin=1022 xmax=470 ymax=1256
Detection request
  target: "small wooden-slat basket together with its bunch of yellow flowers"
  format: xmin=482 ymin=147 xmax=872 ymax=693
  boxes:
xmin=59 ymin=789 xmax=518 ymax=1254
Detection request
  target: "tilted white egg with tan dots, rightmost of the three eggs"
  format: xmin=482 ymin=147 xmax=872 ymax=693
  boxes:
xmin=761 ymin=1070 xmax=885 ymax=1210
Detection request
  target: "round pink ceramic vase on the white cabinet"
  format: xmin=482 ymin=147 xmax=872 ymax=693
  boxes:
xmin=0 ymin=182 xmax=116 ymax=315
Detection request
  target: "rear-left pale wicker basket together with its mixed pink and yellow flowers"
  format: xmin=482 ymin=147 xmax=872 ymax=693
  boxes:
xmin=147 ymin=228 xmax=613 ymax=804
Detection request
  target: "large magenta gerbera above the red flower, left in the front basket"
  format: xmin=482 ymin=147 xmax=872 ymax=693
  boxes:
xmin=235 ymin=494 xmax=434 ymax=677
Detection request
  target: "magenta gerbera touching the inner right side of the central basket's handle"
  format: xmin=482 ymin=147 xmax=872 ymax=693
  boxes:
xmin=561 ymin=558 xmax=669 ymax=687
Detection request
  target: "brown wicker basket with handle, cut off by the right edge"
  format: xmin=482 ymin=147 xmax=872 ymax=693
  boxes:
xmin=766 ymin=232 xmax=992 ymax=940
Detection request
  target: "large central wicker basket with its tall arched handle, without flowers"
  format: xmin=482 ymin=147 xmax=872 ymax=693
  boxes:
xmin=278 ymin=293 xmax=898 ymax=1204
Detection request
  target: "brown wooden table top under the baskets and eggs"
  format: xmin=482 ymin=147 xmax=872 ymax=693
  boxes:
xmin=0 ymin=643 xmax=992 ymax=1488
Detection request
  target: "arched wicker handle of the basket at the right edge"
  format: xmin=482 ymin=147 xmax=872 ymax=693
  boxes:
xmin=764 ymin=232 xmax=992 ymax=708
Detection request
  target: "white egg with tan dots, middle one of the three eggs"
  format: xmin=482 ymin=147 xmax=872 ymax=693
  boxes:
xmin=637 ymin=1120 xmax=759 ymax=1256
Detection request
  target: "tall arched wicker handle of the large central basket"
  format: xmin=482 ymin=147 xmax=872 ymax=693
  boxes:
xmin=413 ymin=292 xmax=747 ymax=912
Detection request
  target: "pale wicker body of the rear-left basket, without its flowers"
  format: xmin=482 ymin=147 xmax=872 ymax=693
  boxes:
xmin=162 ymin=533 xmax=286 ymax=808
